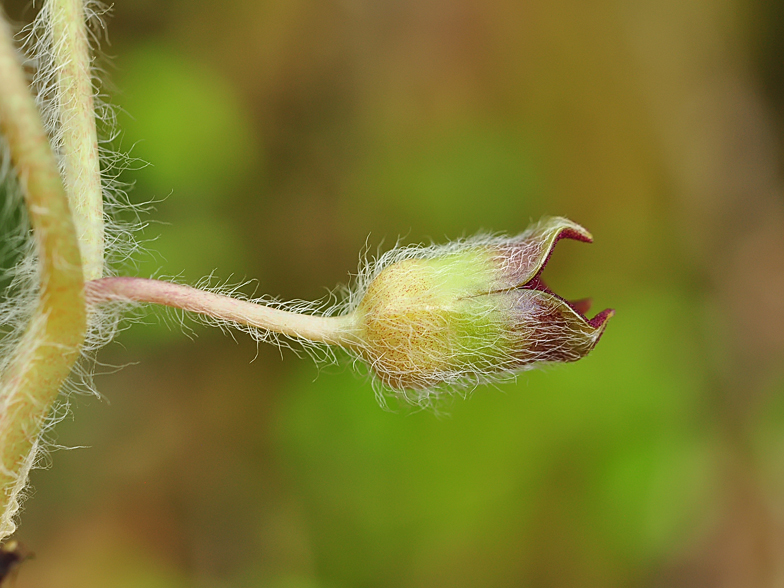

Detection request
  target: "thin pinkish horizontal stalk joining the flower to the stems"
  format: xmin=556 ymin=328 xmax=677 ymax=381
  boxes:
xmin=85 ymin=278 xmax=359 ymax=347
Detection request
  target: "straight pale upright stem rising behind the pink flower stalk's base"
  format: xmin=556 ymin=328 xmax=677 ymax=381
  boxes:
xmin=47 ymin=0 xmax=104 ymax=280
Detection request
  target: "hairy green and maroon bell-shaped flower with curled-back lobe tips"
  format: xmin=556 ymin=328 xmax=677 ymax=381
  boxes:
xmin=354 ymin=217 xmax=613 ymax=400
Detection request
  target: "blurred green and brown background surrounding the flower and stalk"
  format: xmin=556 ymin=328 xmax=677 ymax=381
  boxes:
xmin=3 ymin=0 xmax=784 ymax=588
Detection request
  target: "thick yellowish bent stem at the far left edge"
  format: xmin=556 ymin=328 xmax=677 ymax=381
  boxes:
xmin=0 ymin=14 xmax=86 ymax=540
